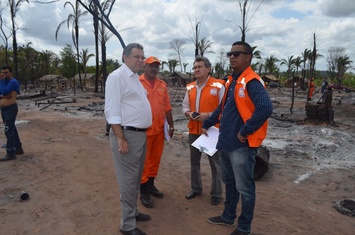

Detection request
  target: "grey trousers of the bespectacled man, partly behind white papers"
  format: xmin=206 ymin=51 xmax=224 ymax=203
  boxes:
xmin=189 ymin=134 xmax=222 ymax=197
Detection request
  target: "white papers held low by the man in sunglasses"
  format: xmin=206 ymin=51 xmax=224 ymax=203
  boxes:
xmin=191 ymin=126 xmax=219 ymax=156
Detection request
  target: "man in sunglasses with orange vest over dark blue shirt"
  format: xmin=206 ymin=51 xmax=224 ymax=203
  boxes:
xmin=202 ymin=42 xmax=272 ymax=235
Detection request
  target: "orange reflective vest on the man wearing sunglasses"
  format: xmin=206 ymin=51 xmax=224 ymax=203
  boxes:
xmin=222 ymin=66 xmax=268 ymax=147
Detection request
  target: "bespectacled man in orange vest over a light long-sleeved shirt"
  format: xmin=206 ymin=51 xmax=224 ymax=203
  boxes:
xmin=182 ymin=56 xmax=225 ymax=205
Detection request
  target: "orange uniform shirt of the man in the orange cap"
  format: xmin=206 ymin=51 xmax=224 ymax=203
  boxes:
xmin=139 ymin=74 xmax=171 ymax=135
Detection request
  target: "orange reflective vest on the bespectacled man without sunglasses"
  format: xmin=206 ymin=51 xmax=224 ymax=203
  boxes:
xmin=186 ymin=77 xmax=224 ymax=135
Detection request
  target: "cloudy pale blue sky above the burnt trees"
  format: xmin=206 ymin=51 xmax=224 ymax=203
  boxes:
xmin=0 ymin=0 xmax=355 ymax=71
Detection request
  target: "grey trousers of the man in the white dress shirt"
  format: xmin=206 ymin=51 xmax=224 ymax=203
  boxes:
xmin=110 ymin=129 xmax=147 ymax=231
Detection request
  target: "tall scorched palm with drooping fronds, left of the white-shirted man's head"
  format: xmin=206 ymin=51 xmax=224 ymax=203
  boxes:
xmin=55 ymin=1 xmax=88 ymax=95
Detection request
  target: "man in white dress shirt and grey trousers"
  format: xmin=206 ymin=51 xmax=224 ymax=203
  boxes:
xmin=105 ymin=43 xmax=152 ymax=235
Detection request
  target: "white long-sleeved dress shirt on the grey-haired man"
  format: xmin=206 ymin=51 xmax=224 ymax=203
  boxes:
xmin=105 ymin=64 xmax=152 ymax=128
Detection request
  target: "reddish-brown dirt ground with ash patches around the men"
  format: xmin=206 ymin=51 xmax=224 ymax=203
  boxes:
xmin=0 ymin=88 xmax=355 ymax=235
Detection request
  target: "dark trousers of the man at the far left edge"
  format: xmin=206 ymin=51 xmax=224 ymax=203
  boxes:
xmin=1 ymin=104 xmax=22 ymax=154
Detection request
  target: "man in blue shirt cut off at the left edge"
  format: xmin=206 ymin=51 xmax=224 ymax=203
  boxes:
xmin=0 ymin=66 xmax=24 ymax=161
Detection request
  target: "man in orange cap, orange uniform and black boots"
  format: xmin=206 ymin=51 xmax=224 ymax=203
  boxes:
xmin=139 ymin=56 xmax=174 ymax=208
